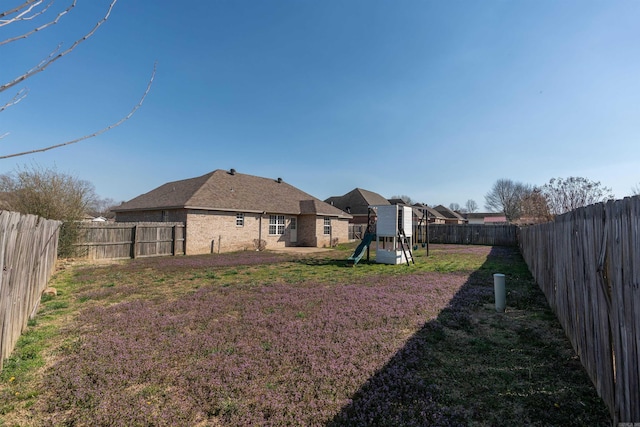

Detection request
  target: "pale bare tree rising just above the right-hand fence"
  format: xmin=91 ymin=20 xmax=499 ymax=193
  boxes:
xmin=542 ymin=176 xmax=615 ymax=215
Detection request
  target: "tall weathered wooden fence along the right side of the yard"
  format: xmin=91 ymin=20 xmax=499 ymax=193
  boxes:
xmin=520 ymin=197 xmax=640 ymax=425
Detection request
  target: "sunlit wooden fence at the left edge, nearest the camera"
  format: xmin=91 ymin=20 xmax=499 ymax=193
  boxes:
xmin=0 ymin=211 xmax=61 ymax=369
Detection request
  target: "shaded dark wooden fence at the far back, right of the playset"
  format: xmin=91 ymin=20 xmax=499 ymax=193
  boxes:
xmin=429 ymin=224 xmax=518 ymax=246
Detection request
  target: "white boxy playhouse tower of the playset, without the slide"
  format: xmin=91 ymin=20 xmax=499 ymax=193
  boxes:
xmin=372 ymin=205 xmax=414 ymax=264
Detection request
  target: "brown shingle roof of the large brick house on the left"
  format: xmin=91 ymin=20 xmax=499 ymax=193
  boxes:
xmin=113 ymin=169 xmax=350 ymax=218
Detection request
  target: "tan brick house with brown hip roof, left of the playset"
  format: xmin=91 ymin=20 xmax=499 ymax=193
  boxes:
xmin=112 ymin=169 xmax=351 ymax=255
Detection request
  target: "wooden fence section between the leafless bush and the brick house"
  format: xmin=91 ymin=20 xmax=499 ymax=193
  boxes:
xmin=75 ymin=222 xmax=185 ymax=260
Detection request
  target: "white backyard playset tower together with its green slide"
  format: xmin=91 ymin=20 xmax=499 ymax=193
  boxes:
xmin=347 ymin=205 xmax=415 ymax=266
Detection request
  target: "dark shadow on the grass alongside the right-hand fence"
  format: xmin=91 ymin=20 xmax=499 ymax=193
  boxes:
xmin=327 ymin=247 xmax=611 ymax=427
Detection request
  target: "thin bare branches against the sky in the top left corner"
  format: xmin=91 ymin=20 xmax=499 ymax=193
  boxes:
xmin=0 ymin=0 xmax=156 ymax=159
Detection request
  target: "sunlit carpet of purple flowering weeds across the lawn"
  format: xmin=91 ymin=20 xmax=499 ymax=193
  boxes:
xmin=46 ymin=274 xmax=466 ymax=426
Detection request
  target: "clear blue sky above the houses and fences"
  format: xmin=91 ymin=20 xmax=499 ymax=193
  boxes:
xmin=0 ymin=0 xmax=640 ymax=209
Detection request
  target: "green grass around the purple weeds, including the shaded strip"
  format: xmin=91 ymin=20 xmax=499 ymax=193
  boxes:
xmin=0 ymin=243 xmax=609 ymax=427
